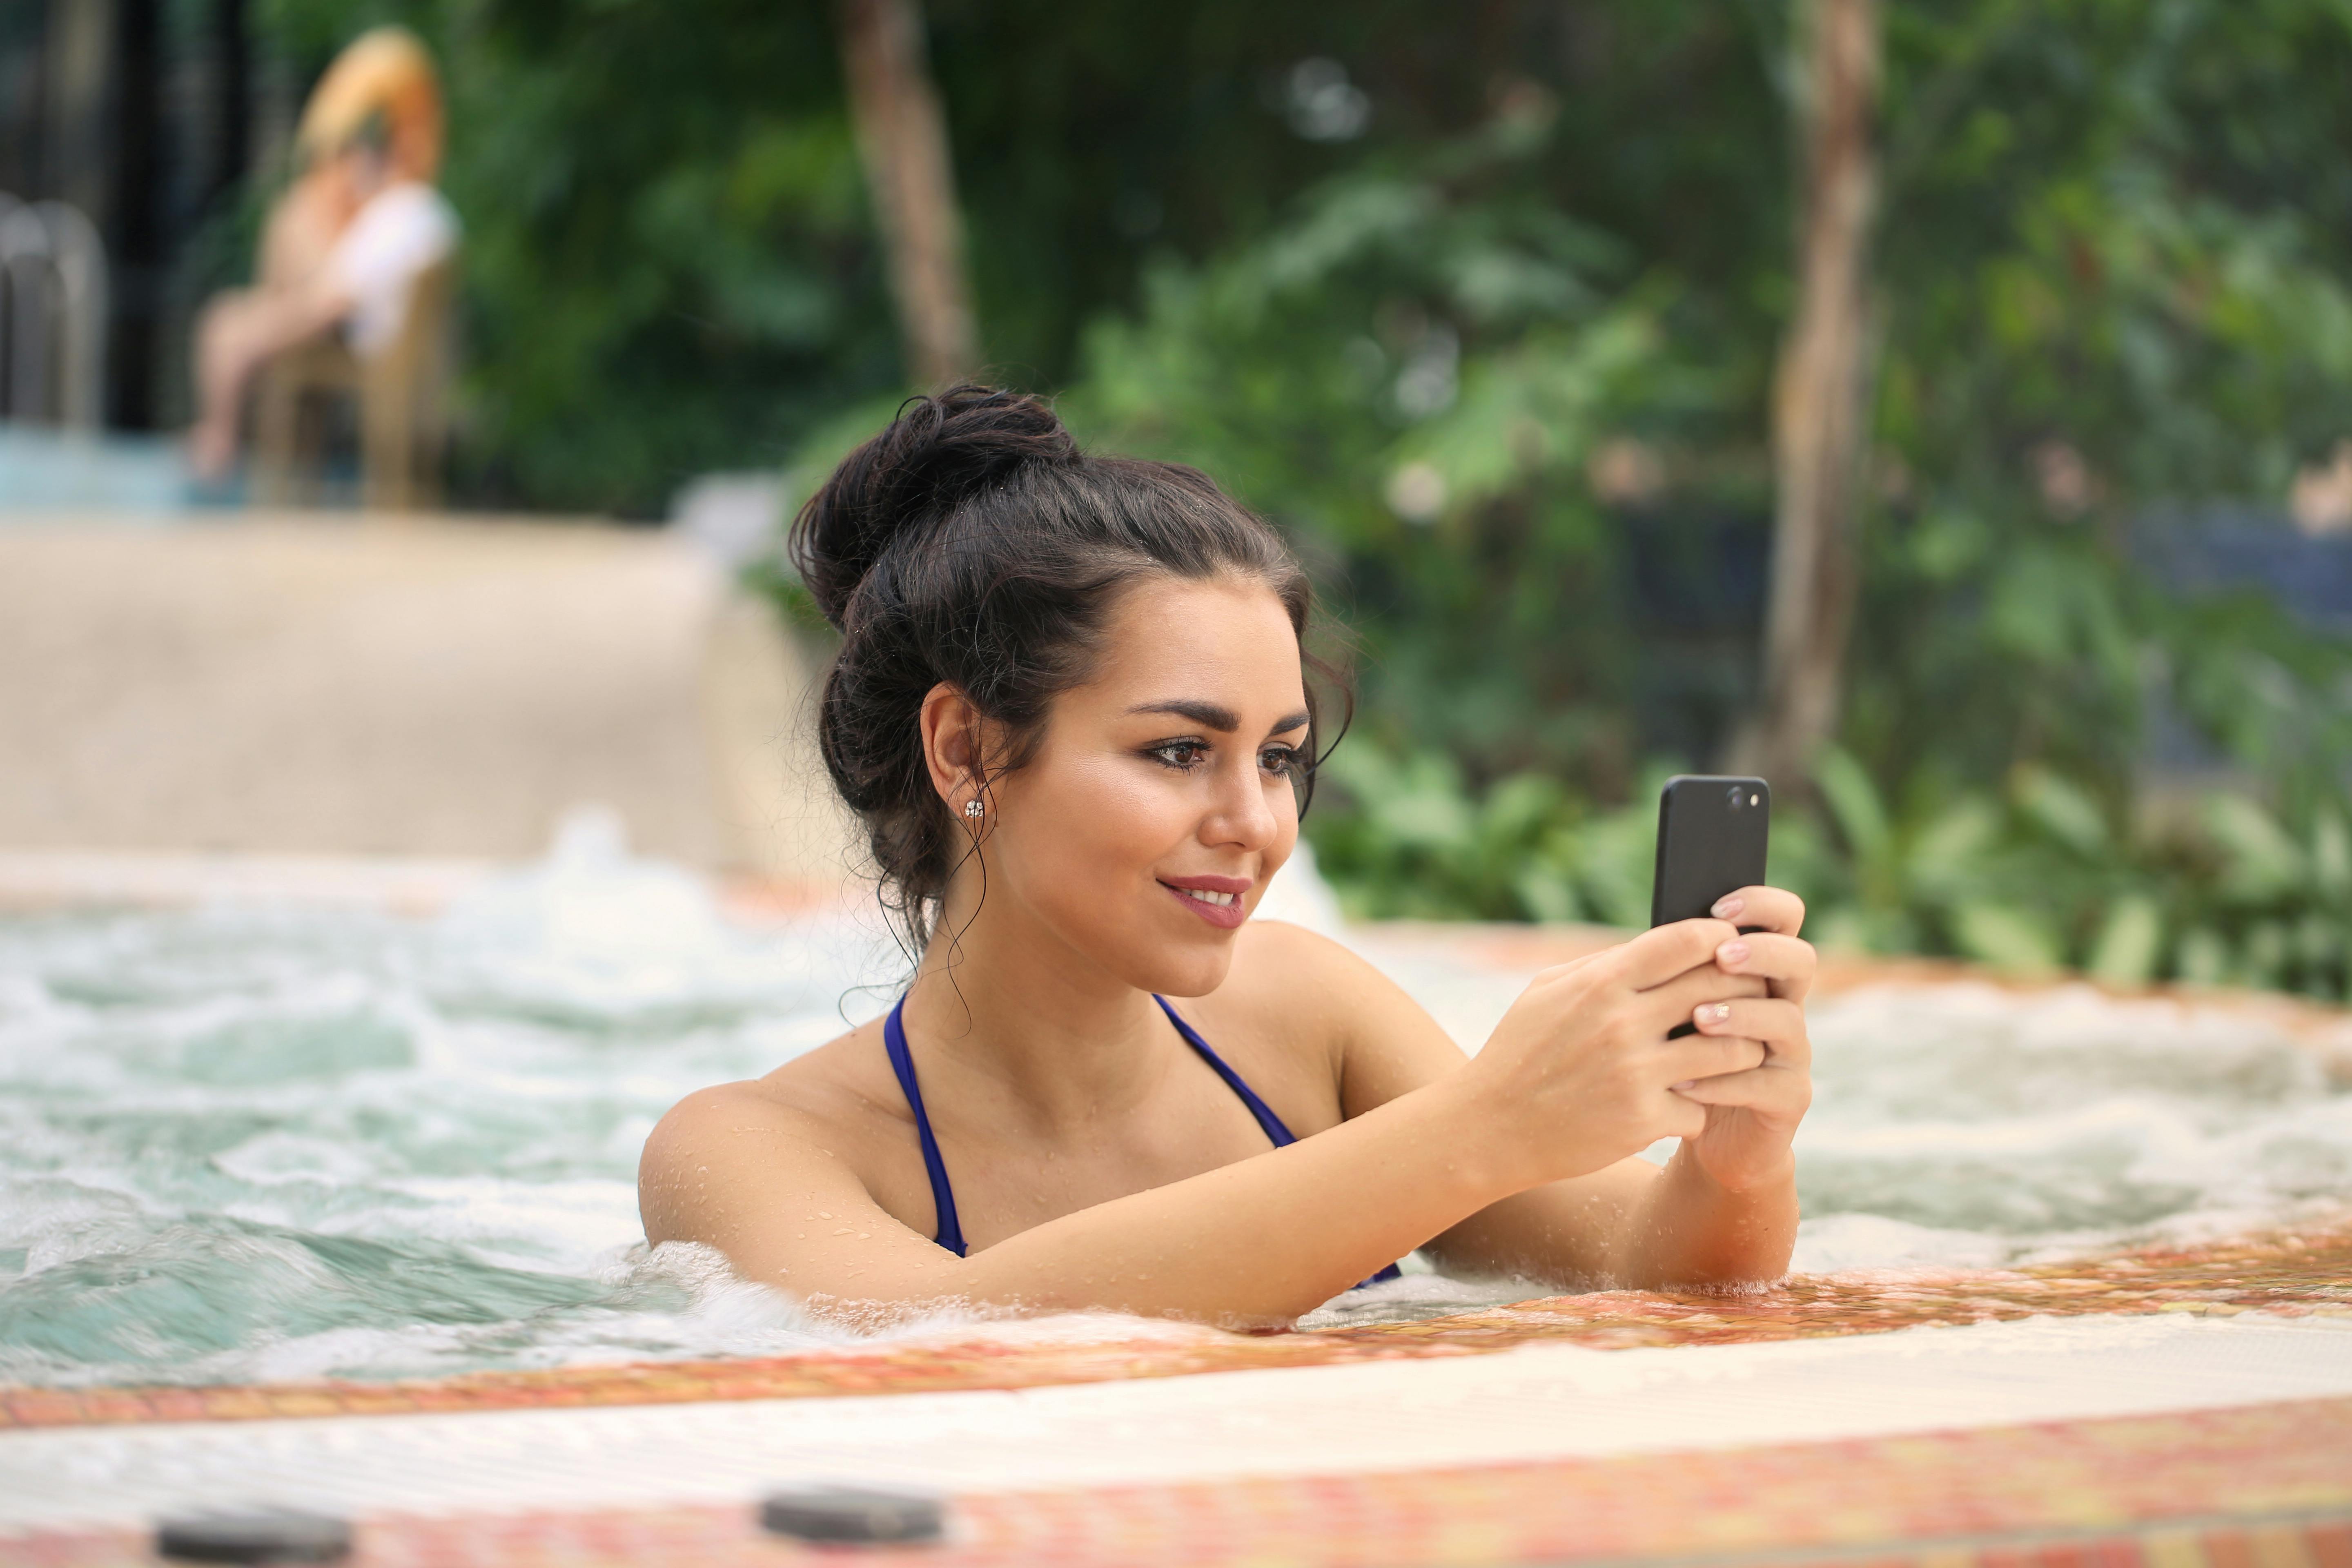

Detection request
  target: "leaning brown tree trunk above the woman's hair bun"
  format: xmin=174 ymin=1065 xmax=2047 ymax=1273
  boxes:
xmin=837 ymin=0 xmax=981 ymax=388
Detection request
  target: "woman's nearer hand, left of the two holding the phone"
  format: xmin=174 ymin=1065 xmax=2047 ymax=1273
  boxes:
xmin=1465 ymin=921 xmax=1768 ymax=1185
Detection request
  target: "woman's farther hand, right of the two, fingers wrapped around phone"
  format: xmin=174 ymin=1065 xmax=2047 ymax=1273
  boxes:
xmin=1661 ymin=886 xmax=1816 ymax=1192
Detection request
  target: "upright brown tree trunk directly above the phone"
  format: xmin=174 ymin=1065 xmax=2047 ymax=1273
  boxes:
xmin=1733 ymin=0 xmax=1879 ymax=795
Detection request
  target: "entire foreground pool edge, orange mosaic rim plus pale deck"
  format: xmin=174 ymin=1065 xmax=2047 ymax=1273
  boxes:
xmin=0 ymin=1225 xmax=2352 ymax=1568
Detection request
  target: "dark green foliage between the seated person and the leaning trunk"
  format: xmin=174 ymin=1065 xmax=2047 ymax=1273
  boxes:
xmin=259 ymin=0 xmax=898 ymax=515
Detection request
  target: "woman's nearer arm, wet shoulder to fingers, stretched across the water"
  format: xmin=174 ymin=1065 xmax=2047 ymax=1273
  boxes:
xmin=640 ymin=922 xmax=1755 ymax=1323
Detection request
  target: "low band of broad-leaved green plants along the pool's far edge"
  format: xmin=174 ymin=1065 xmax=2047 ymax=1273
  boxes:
xmin=1310 ymin=743 xmax=2352 ymax=999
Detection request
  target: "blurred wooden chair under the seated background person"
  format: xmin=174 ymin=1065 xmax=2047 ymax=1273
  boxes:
xmin=254 ymin=258 xmax=456 ymax=510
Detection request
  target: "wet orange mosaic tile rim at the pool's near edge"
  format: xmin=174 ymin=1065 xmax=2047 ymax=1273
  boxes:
xmin=0 ymin=1223 xmax=2352 ymax=1439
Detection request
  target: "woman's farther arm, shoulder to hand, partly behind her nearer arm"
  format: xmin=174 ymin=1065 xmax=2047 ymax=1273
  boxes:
xmin=1287 ymin=889 xmax=1813 ymax=1286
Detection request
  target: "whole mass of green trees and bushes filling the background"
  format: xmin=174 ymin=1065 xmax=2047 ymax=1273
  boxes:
xmin=261 ymin=0 xmax=2352 ymax=994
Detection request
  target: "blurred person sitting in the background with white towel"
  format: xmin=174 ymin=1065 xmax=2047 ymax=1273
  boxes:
xmin=188 ymin=28 xmax=459 ymax=482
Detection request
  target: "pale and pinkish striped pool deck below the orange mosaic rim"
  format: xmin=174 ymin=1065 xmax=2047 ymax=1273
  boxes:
xmin=0 ymin=1319 xmax=2352 ymax=1568
